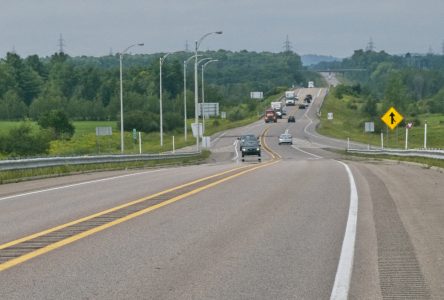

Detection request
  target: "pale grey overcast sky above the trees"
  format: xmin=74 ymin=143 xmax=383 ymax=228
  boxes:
xmin=0 ymin=0 xmax=444 ymax=57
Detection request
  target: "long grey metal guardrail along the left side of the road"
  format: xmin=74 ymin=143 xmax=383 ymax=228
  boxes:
xmin=0 ymin=152 xmax=200 ymax=171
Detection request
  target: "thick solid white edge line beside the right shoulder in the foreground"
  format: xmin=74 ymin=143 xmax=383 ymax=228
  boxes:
xmin=330 ymin=161 xmax=358 ymax=300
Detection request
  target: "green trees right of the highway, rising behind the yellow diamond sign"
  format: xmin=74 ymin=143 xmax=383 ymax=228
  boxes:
xmin=316 ymin=50 xmax=444 ymax=117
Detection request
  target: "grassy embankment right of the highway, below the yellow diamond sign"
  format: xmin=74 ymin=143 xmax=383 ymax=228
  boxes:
xmin=318 ymin=93 xmax=444 ymax=167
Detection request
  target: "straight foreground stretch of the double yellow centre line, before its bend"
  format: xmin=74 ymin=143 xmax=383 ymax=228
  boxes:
xmin=0 ymin=160 xmax=278 ymax=272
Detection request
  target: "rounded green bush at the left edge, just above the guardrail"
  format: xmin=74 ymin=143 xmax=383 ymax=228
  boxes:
xmin=0 ymin=123 xmax=51 ymax=156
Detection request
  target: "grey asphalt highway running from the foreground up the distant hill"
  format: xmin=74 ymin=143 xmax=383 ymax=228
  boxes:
xmin=0 ymin=88 xmax=444 ymax=299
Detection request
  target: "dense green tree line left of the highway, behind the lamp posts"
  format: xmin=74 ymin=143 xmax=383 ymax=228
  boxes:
xmin=0 ymin=50 xmax=304 ymax=125
